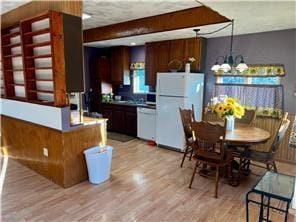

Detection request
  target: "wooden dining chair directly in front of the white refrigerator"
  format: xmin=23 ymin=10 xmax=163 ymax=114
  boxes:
xmin=179 ymin=104 xmax=195 ymax=167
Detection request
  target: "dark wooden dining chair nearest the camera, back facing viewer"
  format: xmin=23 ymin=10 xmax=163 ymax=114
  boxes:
xmin=189 ymin=121 xmax=233 ymax=198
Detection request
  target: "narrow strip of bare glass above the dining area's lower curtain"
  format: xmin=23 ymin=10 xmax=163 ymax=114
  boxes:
xmin=216 ymin=76 xmax=280 ymax=85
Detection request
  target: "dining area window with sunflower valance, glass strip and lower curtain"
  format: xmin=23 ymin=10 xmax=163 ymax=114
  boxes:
xmin=213 ymin=64 xmax=285 ymax=118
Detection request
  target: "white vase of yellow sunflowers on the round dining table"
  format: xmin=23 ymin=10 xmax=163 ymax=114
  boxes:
xmin=211 ymin=95 xmax=245 ymax=130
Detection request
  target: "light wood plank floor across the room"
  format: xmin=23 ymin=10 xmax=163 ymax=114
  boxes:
xmin=1 ymin=140 xmax=296 ymax=222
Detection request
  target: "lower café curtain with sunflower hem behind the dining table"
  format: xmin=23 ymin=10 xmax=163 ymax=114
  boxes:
xmin=214 ymin=84 xmax=283 ymax=118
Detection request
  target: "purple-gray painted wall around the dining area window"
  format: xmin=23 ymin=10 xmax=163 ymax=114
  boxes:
xmin=204 ymin=29 xmax=296 ymax=113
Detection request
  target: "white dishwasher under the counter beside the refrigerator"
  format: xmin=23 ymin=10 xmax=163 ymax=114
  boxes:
xmin=137 ymin=107 xmax=156 ymax=141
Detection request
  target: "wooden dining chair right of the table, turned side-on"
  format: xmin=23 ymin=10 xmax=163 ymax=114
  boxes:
xmin=239 ymin=119 xmax=290 ymax=172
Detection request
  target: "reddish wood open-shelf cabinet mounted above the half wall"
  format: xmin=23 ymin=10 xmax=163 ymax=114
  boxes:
xmin=1 ymin=11 xmax=84 ymax=106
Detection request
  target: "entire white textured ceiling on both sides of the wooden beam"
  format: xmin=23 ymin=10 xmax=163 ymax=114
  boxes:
xmin=0 ymin=0 xmax=296 ymax=47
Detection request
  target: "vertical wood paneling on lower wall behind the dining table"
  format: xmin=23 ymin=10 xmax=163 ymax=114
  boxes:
xmin=203 ymin=113 xmax=296 ymax=163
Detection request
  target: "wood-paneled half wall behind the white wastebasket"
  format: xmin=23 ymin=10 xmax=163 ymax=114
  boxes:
xmin=1 ymin=116 xmax=106 ymax=187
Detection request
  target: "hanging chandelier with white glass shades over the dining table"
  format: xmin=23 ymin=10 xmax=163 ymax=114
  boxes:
xmin=211 ymin=20 xmax=248 ymax=73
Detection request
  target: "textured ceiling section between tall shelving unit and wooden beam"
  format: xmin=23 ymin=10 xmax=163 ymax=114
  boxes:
xmin=83 ymin=0 xmax=201 ymax=29
